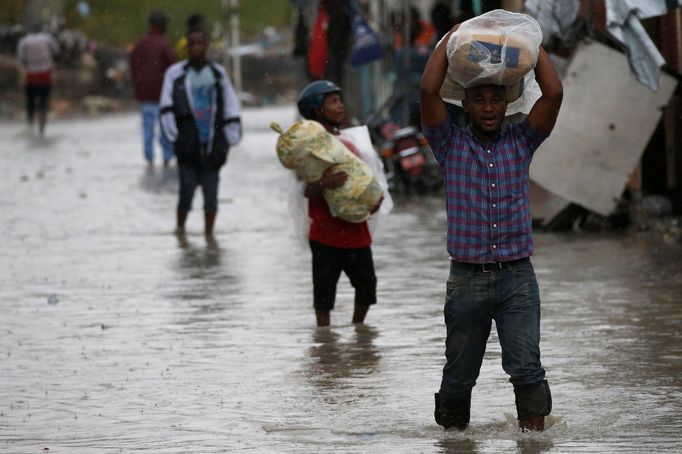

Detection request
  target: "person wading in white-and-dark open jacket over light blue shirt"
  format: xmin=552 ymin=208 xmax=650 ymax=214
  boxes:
xmin=161 ymin=24 xmax=242 ymax=238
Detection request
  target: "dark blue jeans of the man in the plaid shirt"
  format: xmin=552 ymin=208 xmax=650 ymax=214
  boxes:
xmin=440 ymin=259 xmax=545 ymax=401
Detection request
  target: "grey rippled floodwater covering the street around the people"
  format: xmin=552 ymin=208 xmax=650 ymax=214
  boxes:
xmin=0 ymin=107 xmax=682 ymax=454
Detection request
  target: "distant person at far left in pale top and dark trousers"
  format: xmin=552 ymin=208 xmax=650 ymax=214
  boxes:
xmin=17 ymin=25 xmax=59 ymax=136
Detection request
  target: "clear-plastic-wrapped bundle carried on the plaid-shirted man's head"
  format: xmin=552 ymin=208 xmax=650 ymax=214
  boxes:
xmin=440 ymin=9 xmax=542 ymax=114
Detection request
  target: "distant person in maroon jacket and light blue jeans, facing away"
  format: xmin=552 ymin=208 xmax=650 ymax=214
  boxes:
xmin=130 ymin=11 xmax=175 ymax=167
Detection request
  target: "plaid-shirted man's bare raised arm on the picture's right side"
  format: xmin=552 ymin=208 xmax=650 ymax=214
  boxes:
xmin=528 ymin=47 xmax=564 ymax=134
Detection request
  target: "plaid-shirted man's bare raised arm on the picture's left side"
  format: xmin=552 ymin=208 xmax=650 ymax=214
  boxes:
xmin=419 ymin=24 xmax=459 ymax=127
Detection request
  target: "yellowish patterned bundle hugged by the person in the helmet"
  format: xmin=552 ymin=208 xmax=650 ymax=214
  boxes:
xmin=270 ymin=120 xmax=384 ymax=222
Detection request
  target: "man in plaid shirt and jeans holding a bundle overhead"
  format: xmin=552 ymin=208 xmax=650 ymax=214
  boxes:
xmin=420 ymin=16 xmax=563 ymax=431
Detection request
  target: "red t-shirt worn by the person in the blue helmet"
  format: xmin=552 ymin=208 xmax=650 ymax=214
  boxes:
xmin=308 ymin=139 xmax=372 ymax=249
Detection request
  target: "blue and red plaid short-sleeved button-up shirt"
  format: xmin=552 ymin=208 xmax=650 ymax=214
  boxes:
xmin=422 ymin=119 xmax=547 ymax=263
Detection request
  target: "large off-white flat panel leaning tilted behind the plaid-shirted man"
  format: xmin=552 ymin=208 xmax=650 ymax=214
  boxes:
xmin=530 ymin=42 xmax=677 ymax=216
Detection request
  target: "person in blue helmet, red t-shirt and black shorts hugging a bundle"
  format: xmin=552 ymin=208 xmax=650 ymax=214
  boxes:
xmin=297 ymin=80 xmax=383 ymax=326
